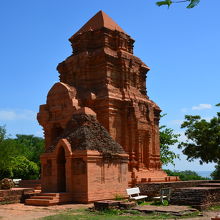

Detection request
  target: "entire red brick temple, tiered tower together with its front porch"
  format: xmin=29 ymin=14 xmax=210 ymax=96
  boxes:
xmin=27 ymin=11 xmax=170 ymax=204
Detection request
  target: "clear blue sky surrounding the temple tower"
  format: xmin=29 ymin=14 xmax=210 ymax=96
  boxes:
xmin=0 ymin=0 xmax=220 ymax=170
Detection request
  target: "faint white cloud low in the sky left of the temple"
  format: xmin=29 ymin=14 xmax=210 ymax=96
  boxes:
xmin=0 ymin=110 xmax=36 ymax=121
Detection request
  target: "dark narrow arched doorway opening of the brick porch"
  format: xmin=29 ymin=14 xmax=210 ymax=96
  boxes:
xmin=57 ymin=147 xmax=66 ymax=192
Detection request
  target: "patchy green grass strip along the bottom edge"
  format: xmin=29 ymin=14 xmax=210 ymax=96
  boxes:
xmin=42 ymin=209 xmax=201 ymax=220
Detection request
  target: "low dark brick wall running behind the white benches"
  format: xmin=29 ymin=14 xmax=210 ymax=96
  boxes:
xmin=136 ymin=180 xmax=213 ymax=197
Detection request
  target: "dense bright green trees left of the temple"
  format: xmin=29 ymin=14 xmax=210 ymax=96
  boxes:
xmin=0 ymin=126 xmax=44 ymax=179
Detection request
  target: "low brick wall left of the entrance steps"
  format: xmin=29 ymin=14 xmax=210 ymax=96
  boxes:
xmin=0 ymin=188 xmax=34 ymax=204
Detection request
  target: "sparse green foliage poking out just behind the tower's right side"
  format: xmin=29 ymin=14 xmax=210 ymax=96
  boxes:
xmin=160 ymin=115 xmax=180 ymax=165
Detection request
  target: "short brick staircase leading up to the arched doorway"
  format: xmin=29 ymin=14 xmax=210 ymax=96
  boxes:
xmin=25 ymin=193 xmax=73 ymax=206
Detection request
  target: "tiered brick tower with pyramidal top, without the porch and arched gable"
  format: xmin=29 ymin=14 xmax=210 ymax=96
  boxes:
xmin=57 ymin=11 xmax=166 ymax=180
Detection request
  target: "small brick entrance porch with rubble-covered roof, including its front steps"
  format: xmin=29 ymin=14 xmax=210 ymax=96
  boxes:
xmin=26 ymin=108 xmax=128 ymax=205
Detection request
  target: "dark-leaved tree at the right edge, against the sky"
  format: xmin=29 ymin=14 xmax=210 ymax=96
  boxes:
xmin=179 ymin=104 xmax=220 ymax=164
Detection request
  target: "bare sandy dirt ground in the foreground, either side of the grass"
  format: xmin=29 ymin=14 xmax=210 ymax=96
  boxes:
xmin=0 ymin=203 xmax=220 ymax=220
